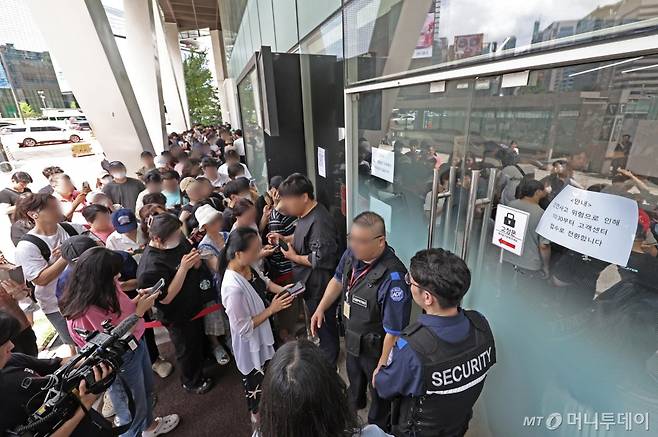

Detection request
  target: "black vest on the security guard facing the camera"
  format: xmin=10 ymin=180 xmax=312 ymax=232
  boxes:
xmin=340 ymin=248 xmax=407 ymax=357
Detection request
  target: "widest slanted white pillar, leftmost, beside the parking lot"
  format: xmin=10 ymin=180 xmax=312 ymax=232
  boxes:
xmin=26 ymin=0 xmax=153 ymax=173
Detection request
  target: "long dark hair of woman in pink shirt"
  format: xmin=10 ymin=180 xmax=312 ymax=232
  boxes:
xmin=60 ymin=247 xmax=123 ymax=320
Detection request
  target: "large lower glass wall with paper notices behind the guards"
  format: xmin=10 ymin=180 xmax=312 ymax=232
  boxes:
xmin=354 ymin=56 xmax=658 ymax=436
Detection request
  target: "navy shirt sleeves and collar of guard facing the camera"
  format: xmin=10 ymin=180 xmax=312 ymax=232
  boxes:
xmin=334 ymin=247 xmax=412 ymax=335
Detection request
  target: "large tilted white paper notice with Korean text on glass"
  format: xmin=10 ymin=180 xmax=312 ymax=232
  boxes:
xmin=537 ymin=185 xmax=638 ymax=267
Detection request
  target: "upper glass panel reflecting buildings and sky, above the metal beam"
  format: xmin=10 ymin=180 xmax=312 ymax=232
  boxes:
xmin=344 ymin=0 xmax=658 ymax=83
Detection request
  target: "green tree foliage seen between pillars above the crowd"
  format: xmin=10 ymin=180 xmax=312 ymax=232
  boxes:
xmin=183 ymin=50 xmax=221 ymax=125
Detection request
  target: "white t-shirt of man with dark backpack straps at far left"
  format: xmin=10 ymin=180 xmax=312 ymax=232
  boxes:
xmin=16 ymin=224 xmax=87 ymax=314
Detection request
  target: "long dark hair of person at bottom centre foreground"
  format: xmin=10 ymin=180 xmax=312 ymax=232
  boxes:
xmin=260 ymin=340 xmax=361 ymax=437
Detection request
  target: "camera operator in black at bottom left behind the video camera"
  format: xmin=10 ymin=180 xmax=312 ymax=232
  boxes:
xmin=0 ymin=311 xmax=110 ymax=437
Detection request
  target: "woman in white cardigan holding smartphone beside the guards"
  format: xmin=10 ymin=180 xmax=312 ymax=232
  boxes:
xmin=219 ymin=228 xmax=295 ymax=426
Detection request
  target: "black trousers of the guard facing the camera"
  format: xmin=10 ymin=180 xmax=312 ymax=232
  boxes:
xmin=345 ymin=353 xmax=391 ymax=431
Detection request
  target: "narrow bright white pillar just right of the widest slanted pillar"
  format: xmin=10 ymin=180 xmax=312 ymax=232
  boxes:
xmin=123 ymin=0 xmax=167 ymax=153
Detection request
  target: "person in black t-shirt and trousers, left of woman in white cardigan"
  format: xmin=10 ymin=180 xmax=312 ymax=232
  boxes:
xmin=137 ymin=213 xmax=217 ymax=394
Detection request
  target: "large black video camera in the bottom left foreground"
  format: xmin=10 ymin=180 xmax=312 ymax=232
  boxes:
xmin=13 ymin=316 xmax=138 ymax=437
